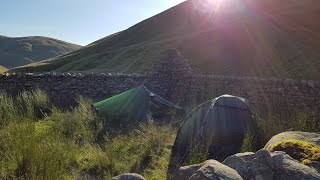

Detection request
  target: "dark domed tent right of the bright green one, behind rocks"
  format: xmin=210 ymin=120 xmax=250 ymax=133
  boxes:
xmin=172 ymin=95 xmax=258 ymax=162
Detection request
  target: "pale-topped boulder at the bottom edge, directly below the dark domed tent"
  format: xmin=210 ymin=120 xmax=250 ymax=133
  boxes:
xmin=174 ymin=160 xmax=242 ymax=180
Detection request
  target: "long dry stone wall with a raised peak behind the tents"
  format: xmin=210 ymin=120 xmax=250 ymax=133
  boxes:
xmin=0 ymin=49 xmax=320 ymax=109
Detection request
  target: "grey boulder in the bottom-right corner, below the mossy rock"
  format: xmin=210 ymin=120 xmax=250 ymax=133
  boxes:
xmin=271 ymin=151 xmax=320 ymax=180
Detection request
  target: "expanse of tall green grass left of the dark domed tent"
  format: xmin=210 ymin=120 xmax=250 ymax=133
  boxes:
xmin=0 ymin=90 xmax=175 ymax=179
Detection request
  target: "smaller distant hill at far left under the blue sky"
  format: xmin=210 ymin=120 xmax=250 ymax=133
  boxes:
xmin=0 ymin=36 xmax=80 ymax=68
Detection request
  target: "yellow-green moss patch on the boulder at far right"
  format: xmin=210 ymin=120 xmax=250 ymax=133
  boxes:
xmin=270 ymin=139 xmax=320 ymax=164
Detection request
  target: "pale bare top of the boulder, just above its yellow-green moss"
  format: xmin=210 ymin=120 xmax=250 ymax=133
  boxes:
xmin=264 ymin=131 xmax=320 ymax=150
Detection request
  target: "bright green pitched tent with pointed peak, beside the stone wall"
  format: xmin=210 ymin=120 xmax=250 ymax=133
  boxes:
xmin=93 ymin=85 xmax=182 ymax=121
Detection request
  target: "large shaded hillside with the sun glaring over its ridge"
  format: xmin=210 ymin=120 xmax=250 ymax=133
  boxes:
xmin=11 ymin=0 xmax=320 ymax=79
